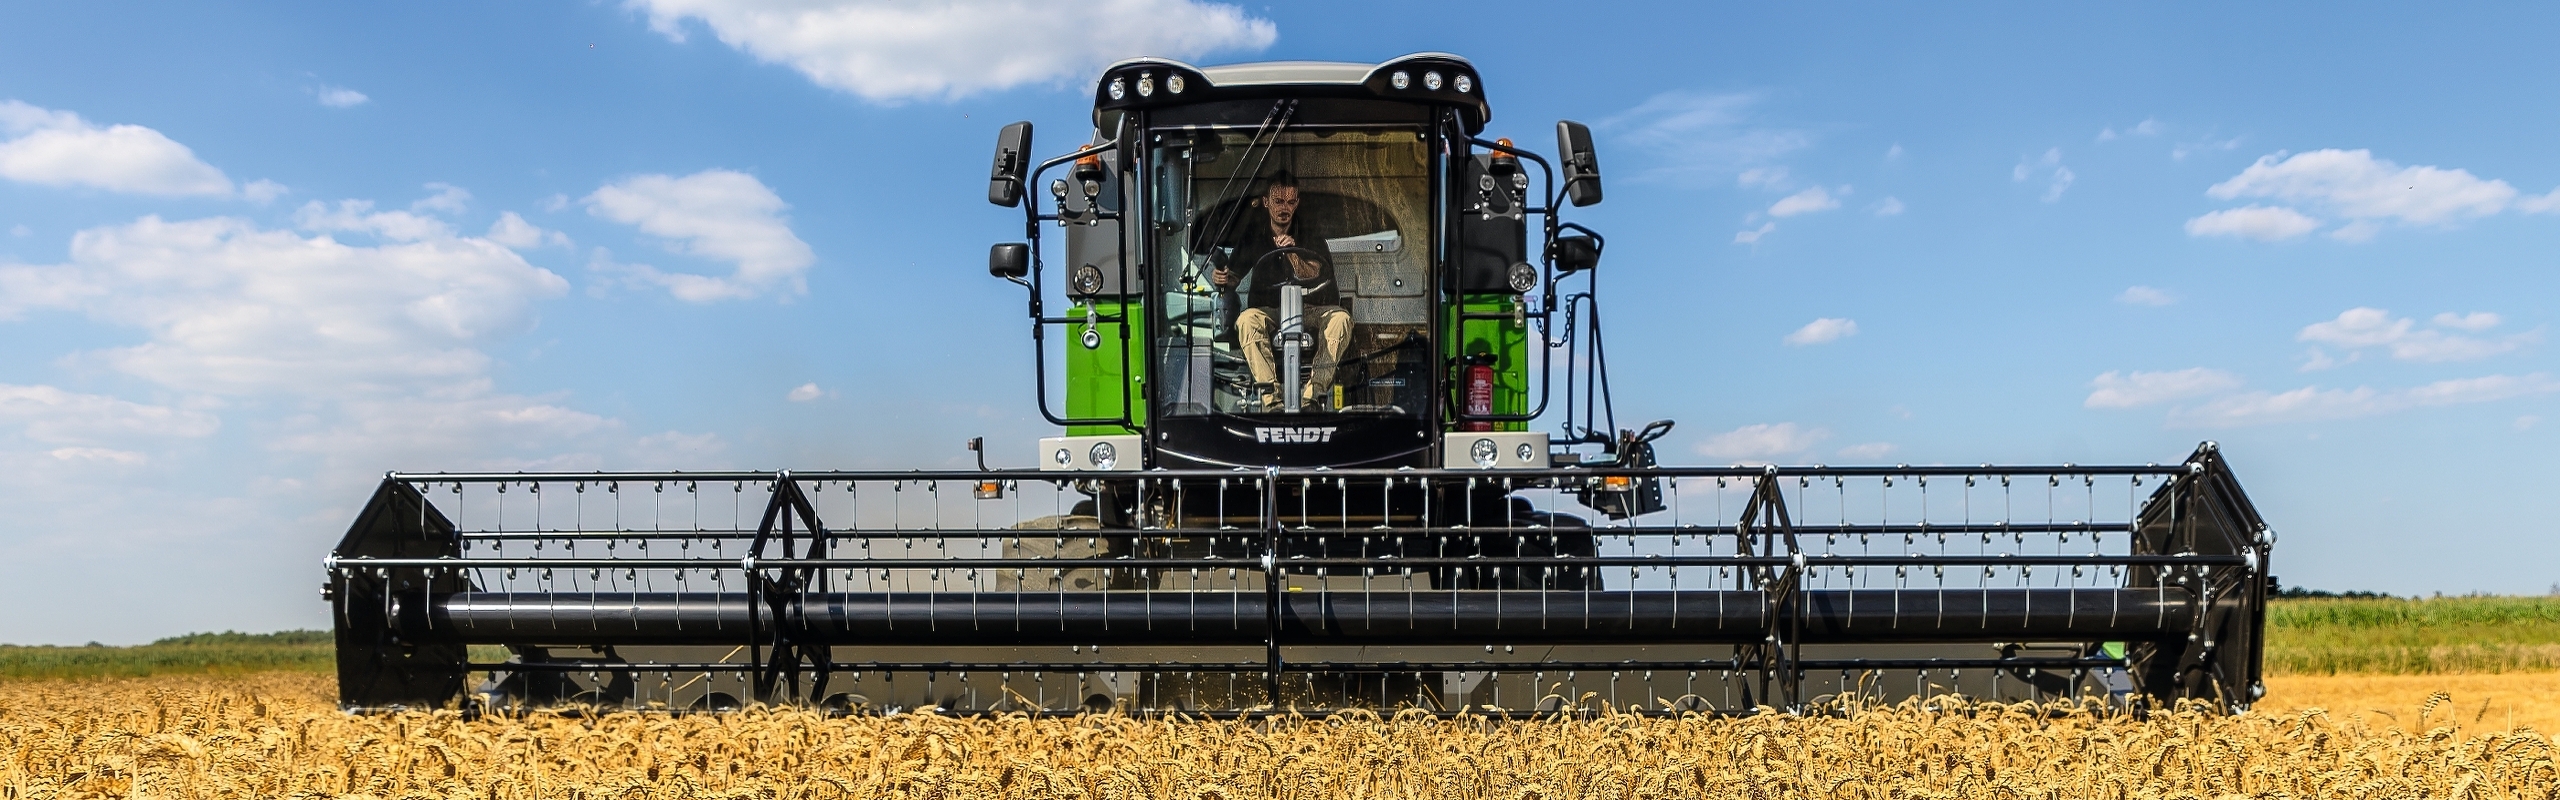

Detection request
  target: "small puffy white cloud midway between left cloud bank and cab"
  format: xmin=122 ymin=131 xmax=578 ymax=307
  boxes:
xmin=579 ymin=169 xmax=817 ymax=303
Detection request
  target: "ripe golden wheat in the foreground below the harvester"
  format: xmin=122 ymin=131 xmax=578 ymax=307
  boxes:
xmin=0 ymin=674 xmax=2560 ymax=800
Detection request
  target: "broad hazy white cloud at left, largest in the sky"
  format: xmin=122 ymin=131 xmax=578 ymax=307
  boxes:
xmin=0 ymin=211 xmax=568 ymax=395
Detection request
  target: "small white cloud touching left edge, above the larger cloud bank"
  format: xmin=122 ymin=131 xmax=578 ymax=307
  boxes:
xmin=0 ymin=100 xmax=230 ymax=195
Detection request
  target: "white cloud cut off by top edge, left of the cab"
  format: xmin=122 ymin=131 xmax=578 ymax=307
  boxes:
xmin=627 ymin=0 xmax=1280 ymax=100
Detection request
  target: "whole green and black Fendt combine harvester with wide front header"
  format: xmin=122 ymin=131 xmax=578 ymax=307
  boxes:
xmin=328 ymin=54 xmax=2273 ymax=715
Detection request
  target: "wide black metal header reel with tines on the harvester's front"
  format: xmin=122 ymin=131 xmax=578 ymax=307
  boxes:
xmin=328 ymin=444 xmax=2273 ymax=708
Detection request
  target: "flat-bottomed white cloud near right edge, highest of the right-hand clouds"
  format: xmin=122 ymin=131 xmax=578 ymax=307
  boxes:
xmin=2186 ymin=149 xmax=2560 ymax=241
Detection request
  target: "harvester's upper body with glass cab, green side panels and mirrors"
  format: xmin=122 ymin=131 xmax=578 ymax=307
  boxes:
xmin=988 ymin=54 xmax=1620 ymax=482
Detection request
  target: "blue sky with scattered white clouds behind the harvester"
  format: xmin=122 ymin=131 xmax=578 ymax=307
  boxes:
xmin=0 ymin=0 xmax=2560 ymax=644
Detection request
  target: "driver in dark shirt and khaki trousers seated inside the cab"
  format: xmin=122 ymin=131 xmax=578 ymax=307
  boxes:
xmin=1208 ymin=169 xmax=1352 ymax=410
